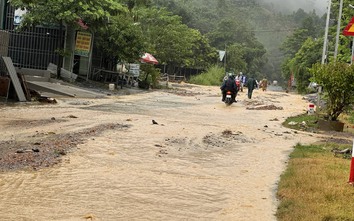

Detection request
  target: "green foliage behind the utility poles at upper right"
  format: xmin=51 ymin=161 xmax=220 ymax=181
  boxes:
xmin=282 ymin=0 xmax=353 ymax=92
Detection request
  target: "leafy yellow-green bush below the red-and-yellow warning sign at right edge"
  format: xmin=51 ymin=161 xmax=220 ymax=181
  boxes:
xmin=310 ymin=61 xmax=354 ymax=121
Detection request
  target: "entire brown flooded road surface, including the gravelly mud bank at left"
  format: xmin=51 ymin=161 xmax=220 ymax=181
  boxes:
xmin=0 ymin=84 xmax=317 ymax=221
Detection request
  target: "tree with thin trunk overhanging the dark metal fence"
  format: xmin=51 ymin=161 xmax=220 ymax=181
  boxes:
xmin=10 ymin=0 xmax=127 ymax=78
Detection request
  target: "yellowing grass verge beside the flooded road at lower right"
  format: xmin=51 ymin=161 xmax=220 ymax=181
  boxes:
xmin=276 ymin=111 xmax=354 ymax=221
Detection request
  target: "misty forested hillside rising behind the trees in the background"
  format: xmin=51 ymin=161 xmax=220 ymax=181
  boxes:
xmin=156 ymin=0 xmax=324 ymax=83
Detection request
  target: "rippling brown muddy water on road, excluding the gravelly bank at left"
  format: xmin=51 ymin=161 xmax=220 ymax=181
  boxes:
xmin=0 ymin=87 xmax=316 ymax=221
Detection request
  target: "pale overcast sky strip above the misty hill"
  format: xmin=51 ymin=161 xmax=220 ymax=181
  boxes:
xmin=263 ymin=0 xmax=328 ymax=15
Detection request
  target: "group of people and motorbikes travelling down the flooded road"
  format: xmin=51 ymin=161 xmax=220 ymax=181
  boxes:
xmin=220 ymin=73 xmax=268 ymax=102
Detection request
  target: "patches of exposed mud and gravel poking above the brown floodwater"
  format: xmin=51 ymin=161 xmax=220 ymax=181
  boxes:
xmin=0 ymin=85 xmax=282 ymax=171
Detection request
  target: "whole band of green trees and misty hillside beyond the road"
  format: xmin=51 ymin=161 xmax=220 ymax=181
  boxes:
xmin=11 ymin=0 xmax=351 ymax=91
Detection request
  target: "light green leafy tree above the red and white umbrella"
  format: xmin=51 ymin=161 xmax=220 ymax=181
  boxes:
xmin=139 ymin=8 xmax=216 ymax=73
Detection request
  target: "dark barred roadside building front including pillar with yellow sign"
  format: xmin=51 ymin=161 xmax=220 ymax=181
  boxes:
xmin=0 ymin=0 xmax=92 ymax=77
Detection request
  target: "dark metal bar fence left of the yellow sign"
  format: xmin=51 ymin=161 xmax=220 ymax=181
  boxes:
xmin=0 ymin=5 xmax=65 ymax=69
